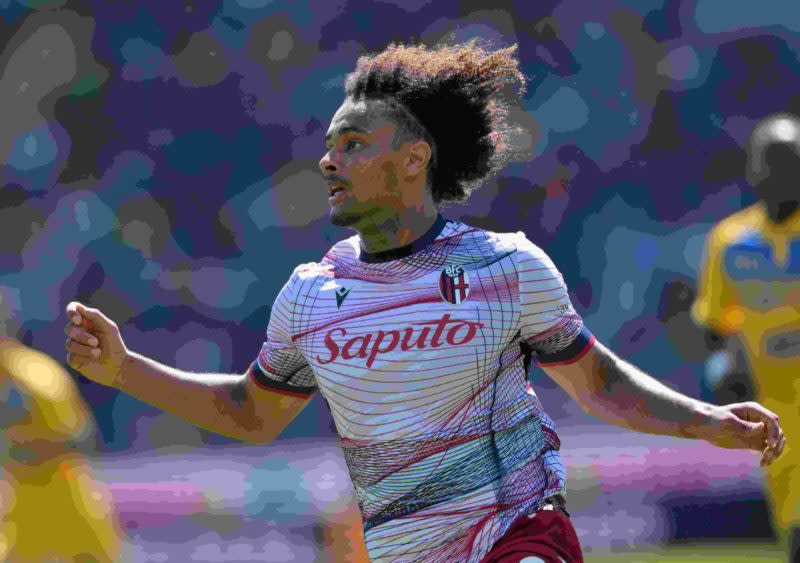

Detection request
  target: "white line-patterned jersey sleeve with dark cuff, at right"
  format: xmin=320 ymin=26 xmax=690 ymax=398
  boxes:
xmin=516 ymin=233 xmax=595 ymax=366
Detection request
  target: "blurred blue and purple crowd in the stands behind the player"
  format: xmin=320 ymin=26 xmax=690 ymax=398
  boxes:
xmin=0 ymin=0 xmax=800 ymax=450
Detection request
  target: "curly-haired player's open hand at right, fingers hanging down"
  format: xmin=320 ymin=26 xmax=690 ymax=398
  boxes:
xmin=704 ymin=402 xmax=786 ymax=467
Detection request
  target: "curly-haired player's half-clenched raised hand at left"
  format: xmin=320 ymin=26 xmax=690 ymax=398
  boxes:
xmin=64 ymin=301 xmax=128 ymax=387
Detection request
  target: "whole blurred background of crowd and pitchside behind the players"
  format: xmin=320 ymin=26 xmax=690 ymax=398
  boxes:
xmin=0 ymin=0 xmax=800 ymax=561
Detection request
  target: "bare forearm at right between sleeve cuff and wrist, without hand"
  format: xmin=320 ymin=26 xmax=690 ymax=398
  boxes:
xmin=579 ymin=349 xmax=716 ymax=438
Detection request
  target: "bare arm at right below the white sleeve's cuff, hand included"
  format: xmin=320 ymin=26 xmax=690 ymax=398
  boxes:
xmin=539 ymin=339 xmax=785 ymax=466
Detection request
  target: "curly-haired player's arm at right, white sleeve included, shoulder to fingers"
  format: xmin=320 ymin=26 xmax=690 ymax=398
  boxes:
xmin=514 ymin=233 xmax=784 ymax=464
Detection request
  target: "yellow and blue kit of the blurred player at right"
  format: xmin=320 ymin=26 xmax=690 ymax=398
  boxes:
xmin=692 ymin=203 xmax=800 ymax=527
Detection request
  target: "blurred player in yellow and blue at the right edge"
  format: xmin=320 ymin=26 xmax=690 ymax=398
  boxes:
xmin=692 ymin=114 xmax=800 ymax=561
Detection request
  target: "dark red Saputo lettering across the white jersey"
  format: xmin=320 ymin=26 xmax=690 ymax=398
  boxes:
xmin=317 ymin=314 xmax=484 ymax=368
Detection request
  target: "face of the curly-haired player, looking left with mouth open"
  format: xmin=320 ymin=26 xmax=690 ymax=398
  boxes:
xmin=319 ymin=99 xmax=404 ymax=228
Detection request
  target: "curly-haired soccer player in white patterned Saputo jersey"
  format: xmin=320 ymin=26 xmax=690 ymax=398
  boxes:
xmin=65 ymin=41 xmax=784 ymax=563
